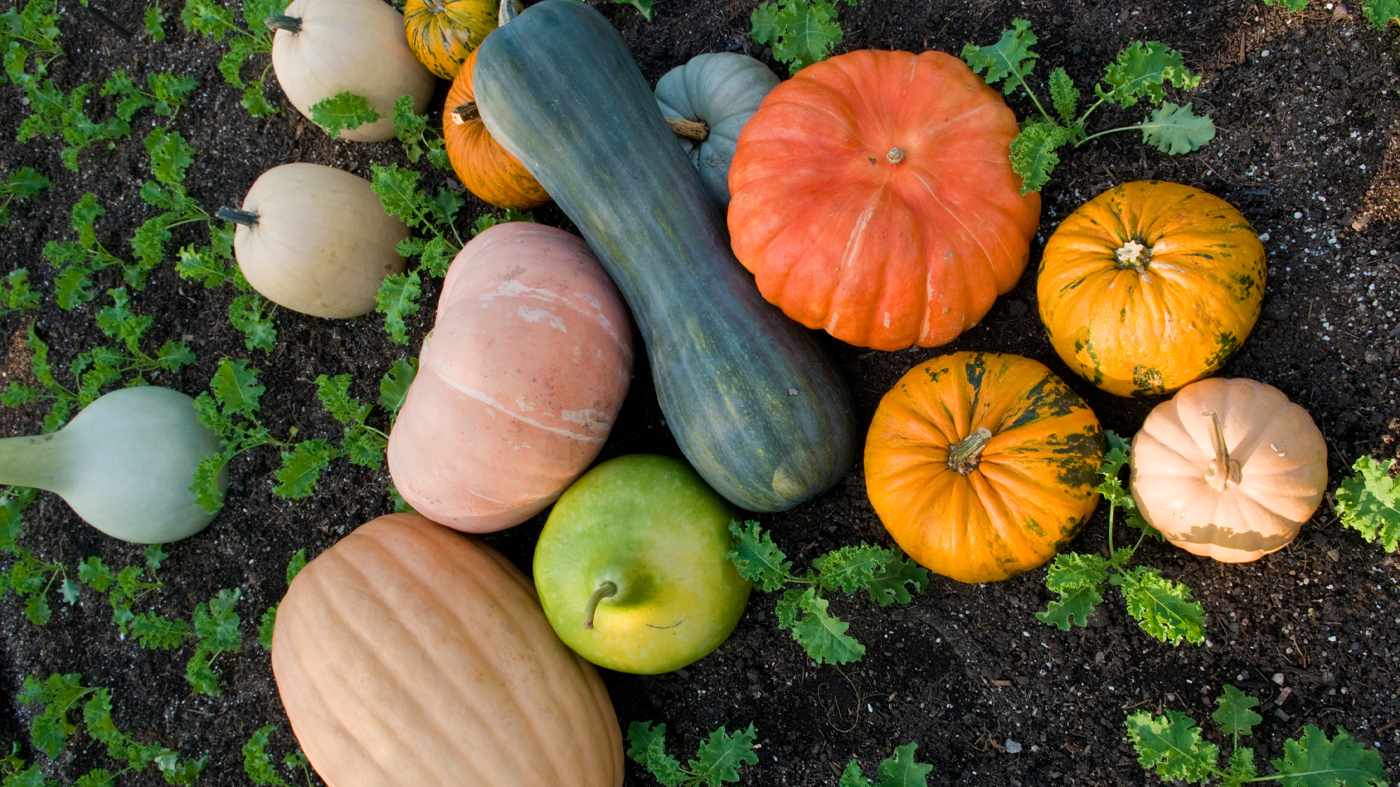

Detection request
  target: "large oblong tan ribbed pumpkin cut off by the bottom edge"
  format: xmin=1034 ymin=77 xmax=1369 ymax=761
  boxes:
xmin=272 ymin=514 xmax=623 ymax=787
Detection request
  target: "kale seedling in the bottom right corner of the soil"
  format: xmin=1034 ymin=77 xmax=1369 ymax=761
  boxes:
xmin=1127 ymin=685 xmax=1386 ymax=787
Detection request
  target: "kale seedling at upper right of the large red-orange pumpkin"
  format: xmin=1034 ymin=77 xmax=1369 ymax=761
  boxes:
xmin=962 ymin=20 xmax=1215 ymax=193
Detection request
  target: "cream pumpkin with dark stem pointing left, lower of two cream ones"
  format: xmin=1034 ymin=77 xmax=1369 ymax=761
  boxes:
xmin=218 ymin=164 xmax=409 ymax=319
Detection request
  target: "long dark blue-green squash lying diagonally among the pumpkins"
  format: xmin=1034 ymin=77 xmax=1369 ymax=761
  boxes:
xmin=472 ymin=0 xmax=858 ymax=511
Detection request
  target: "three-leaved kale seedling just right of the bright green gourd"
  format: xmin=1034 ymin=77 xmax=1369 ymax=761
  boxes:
xmin=729 ymin=521 xmax=928 ymax=664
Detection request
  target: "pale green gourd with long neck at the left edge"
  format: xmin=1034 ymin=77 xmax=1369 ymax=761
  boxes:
xmin=0 ymin=386 xmax=228 ymax=543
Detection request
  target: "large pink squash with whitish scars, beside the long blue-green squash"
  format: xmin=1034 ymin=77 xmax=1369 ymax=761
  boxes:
xmin=389 ymin=223 xmax=633 ymax=532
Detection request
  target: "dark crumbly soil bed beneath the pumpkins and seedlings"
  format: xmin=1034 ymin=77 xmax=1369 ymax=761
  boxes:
xmin=0 ymin=0 xmax=1400 ymax=787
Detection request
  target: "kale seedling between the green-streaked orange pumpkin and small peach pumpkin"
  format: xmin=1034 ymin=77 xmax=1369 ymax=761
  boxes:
xmin=1036 ymin=431 xmax=1205 ymax=646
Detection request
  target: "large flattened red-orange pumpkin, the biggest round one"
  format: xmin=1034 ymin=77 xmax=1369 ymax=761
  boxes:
xmin=729 ymin=50 xmax=1040 ymax=350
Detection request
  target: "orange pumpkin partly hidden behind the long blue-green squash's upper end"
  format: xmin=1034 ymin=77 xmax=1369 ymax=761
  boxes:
xmin=442 ymin=49 xmax=549 ymax=210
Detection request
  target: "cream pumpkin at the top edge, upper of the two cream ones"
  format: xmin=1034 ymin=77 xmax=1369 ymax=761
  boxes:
xmin=267 ymin=0 xmax=437 ymax=141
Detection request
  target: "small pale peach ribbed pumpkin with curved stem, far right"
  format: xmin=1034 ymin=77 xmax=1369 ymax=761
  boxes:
xmin=1131 ymin=378 xmax=1327 ymax=563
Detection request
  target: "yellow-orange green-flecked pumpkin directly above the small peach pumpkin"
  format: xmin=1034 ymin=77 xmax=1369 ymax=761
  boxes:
xmin=1036 ymin=181 xmax=1267 ymax=396
